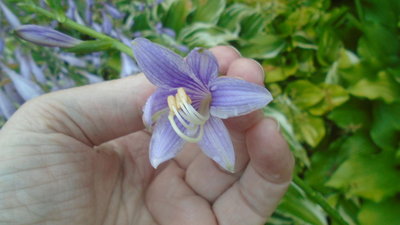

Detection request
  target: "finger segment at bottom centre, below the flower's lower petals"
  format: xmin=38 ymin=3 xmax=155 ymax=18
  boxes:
xmin=146 ymin=161 xmax=216 ymax=225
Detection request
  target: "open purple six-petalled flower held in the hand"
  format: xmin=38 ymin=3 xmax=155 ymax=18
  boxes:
xmin=133 ymin=38 xmax=272 ymax=171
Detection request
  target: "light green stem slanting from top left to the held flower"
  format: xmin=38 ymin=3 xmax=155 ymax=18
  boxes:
xmin=22 ymin=4 xmax=133 ymax=57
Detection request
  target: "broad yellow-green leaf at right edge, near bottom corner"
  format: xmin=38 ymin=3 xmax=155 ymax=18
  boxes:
xmin=327 ymin=152 xmax=400 ymax=202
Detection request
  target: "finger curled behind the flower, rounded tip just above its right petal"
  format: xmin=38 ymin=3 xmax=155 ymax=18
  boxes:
xmin=186 ymin=55 xmax=264 ymax=202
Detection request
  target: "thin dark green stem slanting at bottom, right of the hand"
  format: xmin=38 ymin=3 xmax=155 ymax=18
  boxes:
xmin=293 ymin=176 xmax=348 ymax=225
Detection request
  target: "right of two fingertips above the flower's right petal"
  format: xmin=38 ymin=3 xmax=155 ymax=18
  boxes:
xmin=226 ymin=58 xmax=265 ymax=85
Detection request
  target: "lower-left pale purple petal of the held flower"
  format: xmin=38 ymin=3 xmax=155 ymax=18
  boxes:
xmin=150 ymin=113 xmax=184 ymax=168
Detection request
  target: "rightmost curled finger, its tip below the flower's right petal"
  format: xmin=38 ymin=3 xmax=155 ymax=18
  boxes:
xmin=213 ymin=119 xmax=294 ymax=225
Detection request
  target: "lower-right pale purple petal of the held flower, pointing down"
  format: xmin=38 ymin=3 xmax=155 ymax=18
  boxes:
xmin=198 ymin=116 xmax=235 ymax=172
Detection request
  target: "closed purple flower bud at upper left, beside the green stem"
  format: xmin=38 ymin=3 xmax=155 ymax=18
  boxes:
xmin=15 ymin=25 xmax=82 ymax=48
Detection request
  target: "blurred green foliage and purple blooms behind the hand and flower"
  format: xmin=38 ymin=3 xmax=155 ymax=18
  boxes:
xmin=0 ymin=0 xmax=400 ymax=225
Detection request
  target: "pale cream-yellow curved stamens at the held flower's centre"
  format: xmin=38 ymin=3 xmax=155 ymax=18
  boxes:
xmin=167 ymin=88 xmax=211 ymax=143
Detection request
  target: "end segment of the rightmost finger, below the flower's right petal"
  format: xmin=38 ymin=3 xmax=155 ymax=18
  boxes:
xmin=246 ymin=118 xmax=294 ymax=183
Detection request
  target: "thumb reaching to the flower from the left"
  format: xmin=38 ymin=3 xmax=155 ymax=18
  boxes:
xmin=8 ymin=74 xmax=154 ymax=146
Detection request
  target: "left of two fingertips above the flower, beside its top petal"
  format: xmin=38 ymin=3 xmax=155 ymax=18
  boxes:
xmin=210 ymin=46 xmax=240 ymax=75
